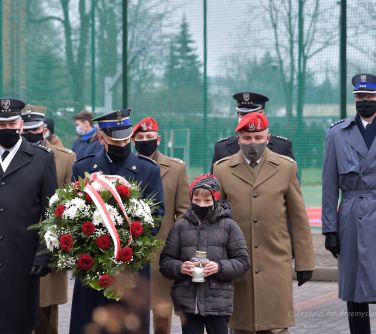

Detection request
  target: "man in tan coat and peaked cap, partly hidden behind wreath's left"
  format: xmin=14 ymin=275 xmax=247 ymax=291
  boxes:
xmin=21 ymin=104 xmax=76 ymax=334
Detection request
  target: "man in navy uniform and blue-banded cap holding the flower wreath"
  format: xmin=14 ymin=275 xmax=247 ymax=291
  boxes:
xmin=69 ymin=108 xmax=164 ymax=334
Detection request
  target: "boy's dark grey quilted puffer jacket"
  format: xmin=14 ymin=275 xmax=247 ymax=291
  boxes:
xmin=159 ymin=204 xmax=250 ymax=316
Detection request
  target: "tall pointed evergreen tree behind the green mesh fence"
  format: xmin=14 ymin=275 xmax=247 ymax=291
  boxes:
xmin=161 ymin=17 xmax=207 ymax=165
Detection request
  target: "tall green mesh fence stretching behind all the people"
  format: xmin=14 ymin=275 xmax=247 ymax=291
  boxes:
xmin=0 ymin=0 xmax=376 ymax=206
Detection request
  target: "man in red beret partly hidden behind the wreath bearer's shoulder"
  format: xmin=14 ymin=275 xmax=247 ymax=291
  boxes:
xmin=132 ymin=117 xmax=190 ymax=334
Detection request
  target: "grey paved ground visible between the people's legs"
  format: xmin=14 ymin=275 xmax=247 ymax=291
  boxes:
xmin=59 ymin=282 xmax=376 ymax=334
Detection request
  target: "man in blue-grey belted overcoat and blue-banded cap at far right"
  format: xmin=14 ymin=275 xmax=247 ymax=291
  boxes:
xmin=322 ymin=74 xmax=376 ymax=334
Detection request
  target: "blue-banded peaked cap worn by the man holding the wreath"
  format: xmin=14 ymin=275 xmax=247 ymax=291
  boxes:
xmin=93 ymin=108 xmax=132 ymax=140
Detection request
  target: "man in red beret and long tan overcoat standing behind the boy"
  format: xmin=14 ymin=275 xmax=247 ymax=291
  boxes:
xmin=214 ymin=112 xmax=314 ymax=334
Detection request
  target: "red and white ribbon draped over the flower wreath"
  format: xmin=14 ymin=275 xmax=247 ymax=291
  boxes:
xmin=84 ymin=173 xmax=132 ymax=259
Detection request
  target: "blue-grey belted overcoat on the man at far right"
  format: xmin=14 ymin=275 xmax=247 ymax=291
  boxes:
xmin=322 ymin=116 xmax=376 ymax=303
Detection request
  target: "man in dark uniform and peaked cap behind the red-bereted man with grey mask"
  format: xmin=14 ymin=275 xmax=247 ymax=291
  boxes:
xmin=211 ymin=92 xmax=295 ymax=170
